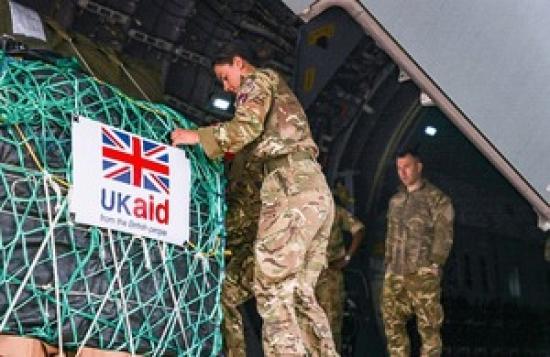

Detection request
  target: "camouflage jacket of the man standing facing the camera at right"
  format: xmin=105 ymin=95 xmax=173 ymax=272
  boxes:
xmin=385 ymin=180 xmax=454 ymax=275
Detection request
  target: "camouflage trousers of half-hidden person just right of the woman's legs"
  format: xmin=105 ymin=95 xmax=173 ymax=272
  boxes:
xmin=315 ymin=268 xmax=346 ymax=352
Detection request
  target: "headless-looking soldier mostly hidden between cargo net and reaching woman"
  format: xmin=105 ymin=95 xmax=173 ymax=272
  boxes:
xmin=222 ymin=145 xmax=263 ymax=357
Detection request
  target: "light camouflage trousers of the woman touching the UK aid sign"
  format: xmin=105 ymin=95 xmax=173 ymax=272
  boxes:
xmin=254 ymin=162 xmax=338 ymax=357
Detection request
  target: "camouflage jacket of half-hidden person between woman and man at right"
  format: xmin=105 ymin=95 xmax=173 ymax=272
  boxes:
xmin=327 ymin=205 xmax=365 ymax=263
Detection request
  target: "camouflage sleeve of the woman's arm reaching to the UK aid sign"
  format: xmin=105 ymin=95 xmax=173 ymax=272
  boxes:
xmin=199 ymin=72 xmax=273 ymax=158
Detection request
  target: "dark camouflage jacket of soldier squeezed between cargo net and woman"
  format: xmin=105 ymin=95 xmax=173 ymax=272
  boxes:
xmin=225 ymin=145 xmax=263 ymax=249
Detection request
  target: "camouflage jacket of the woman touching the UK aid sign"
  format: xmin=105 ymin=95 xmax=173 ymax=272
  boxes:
xmin=199 ymin=69 xmax=318 ymax=162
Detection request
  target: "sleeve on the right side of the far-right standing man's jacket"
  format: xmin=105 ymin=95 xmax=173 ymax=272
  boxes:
xmin=431 ymin=195 xmax=454 ymax=265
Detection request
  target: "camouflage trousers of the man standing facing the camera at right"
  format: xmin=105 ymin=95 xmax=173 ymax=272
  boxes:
xmin=382 ymin=268 xmax=443 ymax=357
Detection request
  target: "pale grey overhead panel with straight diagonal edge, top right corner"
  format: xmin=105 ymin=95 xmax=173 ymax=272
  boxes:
xmin=285 ymin=0 xmax=550 ymax=228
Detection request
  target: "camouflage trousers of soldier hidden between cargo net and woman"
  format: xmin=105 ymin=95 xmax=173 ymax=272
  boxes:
xmin=221 ymin=244 xmax=254 ymax=357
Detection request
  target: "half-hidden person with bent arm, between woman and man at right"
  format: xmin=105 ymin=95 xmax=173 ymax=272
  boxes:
xmin=315 ymin=205 xmax=365 ymax=352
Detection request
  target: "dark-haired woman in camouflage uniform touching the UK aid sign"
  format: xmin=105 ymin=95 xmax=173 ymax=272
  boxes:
xmin=172 ymin=44 xmax=338 ymax=357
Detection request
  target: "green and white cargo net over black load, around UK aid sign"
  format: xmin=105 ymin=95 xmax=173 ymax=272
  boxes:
xmin=0 ymin=52 xmax=225 ymax=356
